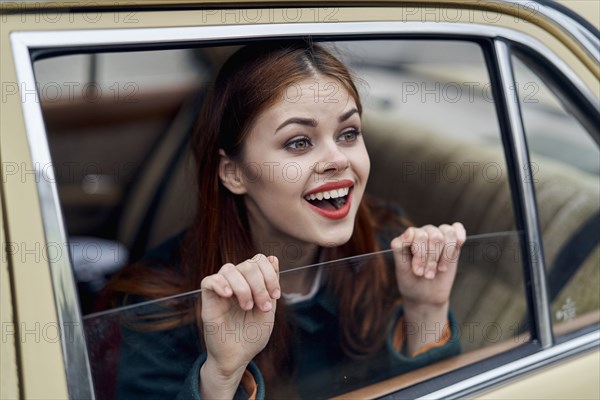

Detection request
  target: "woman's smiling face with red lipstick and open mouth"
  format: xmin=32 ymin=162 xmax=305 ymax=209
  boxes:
xmin=223 ymin=76 xmax=370 ymax=248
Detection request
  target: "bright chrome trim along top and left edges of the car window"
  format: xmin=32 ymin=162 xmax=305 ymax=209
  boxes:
xmin=10 ymin=22 xmax=597 ymax=398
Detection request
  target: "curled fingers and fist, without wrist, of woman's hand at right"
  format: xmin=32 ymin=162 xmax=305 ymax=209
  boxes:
xmin=391 ymin=222 xmax=466 ymax=307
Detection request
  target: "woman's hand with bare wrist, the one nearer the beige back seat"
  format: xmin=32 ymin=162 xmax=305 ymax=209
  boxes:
xmin=391 ymin=222 xmax=467 ymax=354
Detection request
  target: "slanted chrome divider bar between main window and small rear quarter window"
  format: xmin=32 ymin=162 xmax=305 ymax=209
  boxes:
xmin=494 ymin=40 xmax=554 ymax=348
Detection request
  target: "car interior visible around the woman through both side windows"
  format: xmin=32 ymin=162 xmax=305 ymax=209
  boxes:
xmin=34 ymin=39 xmax=600 ymax=397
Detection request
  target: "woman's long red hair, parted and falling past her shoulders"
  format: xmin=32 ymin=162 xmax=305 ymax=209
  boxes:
xmin=110 ymin=40 xmax=399 ymax=381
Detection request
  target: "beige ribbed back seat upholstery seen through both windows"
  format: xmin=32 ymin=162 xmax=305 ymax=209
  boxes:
xmin=363 ymin=110 xmax=600 ymax=350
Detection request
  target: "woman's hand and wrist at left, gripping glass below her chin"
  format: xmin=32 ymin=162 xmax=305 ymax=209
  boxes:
xmin=200 ymin=254 xmax=281 ymax=398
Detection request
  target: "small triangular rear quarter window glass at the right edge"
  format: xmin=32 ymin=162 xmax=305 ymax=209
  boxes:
xmin=513 ymin=55 xmax=600 ymax=334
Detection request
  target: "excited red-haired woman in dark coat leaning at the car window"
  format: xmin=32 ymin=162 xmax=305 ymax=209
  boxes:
xmin=111 ymin=41 xmax=466 ymax=398
